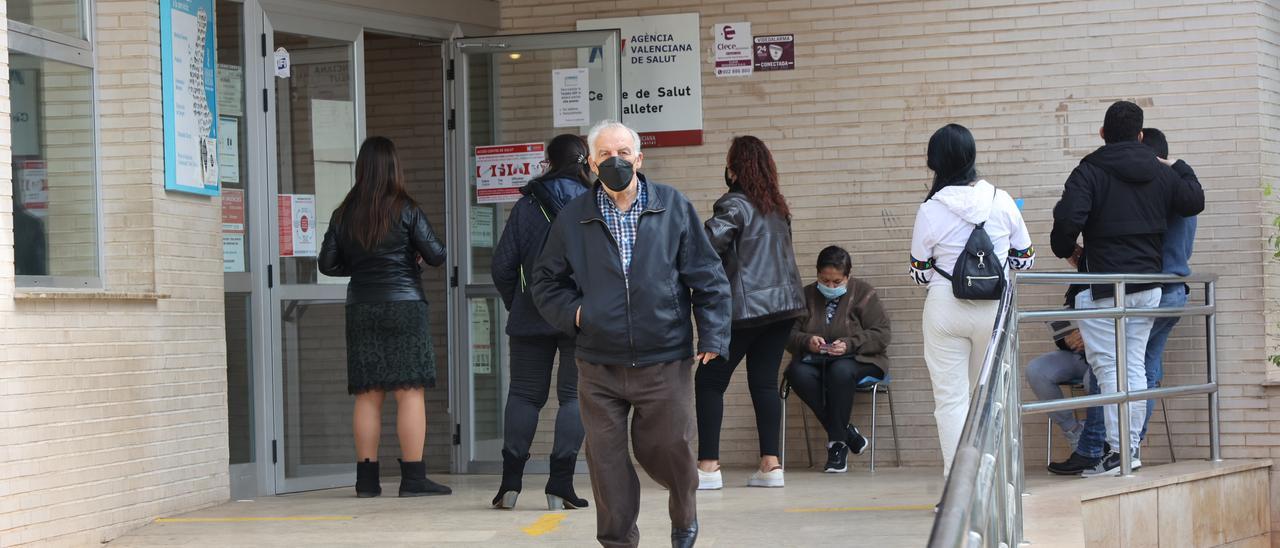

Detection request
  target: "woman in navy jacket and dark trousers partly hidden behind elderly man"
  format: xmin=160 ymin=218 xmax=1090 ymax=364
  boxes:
xmin=492 ymin=134 xmax=591 ymax=510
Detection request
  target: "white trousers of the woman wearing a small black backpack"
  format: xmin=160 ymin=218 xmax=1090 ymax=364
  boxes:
xmin=924 ymin=284 xmax=1000 ymax=475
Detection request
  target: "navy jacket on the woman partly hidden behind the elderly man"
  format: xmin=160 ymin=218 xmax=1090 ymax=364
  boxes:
xmin=492 ymin=177 xmax=589 ymax=337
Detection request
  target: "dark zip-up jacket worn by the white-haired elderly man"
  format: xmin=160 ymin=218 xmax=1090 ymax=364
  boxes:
xmin=530 ymin=175 xmax=733 ymax=366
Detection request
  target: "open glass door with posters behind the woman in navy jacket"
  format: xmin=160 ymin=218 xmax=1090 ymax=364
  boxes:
xmin=445 ymin=31 xmax=622 ymax=472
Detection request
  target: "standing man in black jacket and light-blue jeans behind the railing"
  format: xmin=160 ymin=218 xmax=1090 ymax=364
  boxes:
xmin=1050 ymin=101 xmax=1204 ymax=476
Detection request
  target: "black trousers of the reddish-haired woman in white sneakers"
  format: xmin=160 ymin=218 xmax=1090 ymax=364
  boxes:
xmin=694 ymin=319 xmax=795 ymax=461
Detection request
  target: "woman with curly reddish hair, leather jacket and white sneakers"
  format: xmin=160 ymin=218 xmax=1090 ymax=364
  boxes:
xmin=694 ymin=136 xmax=805 ymax=489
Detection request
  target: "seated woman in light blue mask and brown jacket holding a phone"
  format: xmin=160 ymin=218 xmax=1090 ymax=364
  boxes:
xmin=785 ymin=246 xmax=890 ymax=472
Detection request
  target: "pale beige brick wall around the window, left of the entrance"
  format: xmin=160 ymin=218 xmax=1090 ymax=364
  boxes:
xmin=0 ymin=0 xmax=228 ymax=545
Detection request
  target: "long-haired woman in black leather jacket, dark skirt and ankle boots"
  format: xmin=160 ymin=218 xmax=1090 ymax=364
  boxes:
xmin=320 ymin=137 xmax=452 ymax=498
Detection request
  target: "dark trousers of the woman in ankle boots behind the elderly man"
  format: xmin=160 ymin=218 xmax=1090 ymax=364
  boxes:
xmin=502 ymin=337 xmax=582 ymax=460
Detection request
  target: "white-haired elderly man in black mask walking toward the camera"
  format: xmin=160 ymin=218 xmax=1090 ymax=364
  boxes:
xmin=532 ymin=122 xmax=731 ymax=547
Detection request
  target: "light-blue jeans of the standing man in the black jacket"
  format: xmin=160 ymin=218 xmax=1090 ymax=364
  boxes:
xmin=1075 ymin=287 xmax=1161 ymax=455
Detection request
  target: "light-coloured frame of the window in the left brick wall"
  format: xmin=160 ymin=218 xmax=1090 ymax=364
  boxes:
xmin=5 ymin=0 xmax=106 ymax=289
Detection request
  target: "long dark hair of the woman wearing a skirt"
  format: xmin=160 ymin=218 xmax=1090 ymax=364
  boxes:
xmin=333 ymin=137 xmax=417 ymax=250
